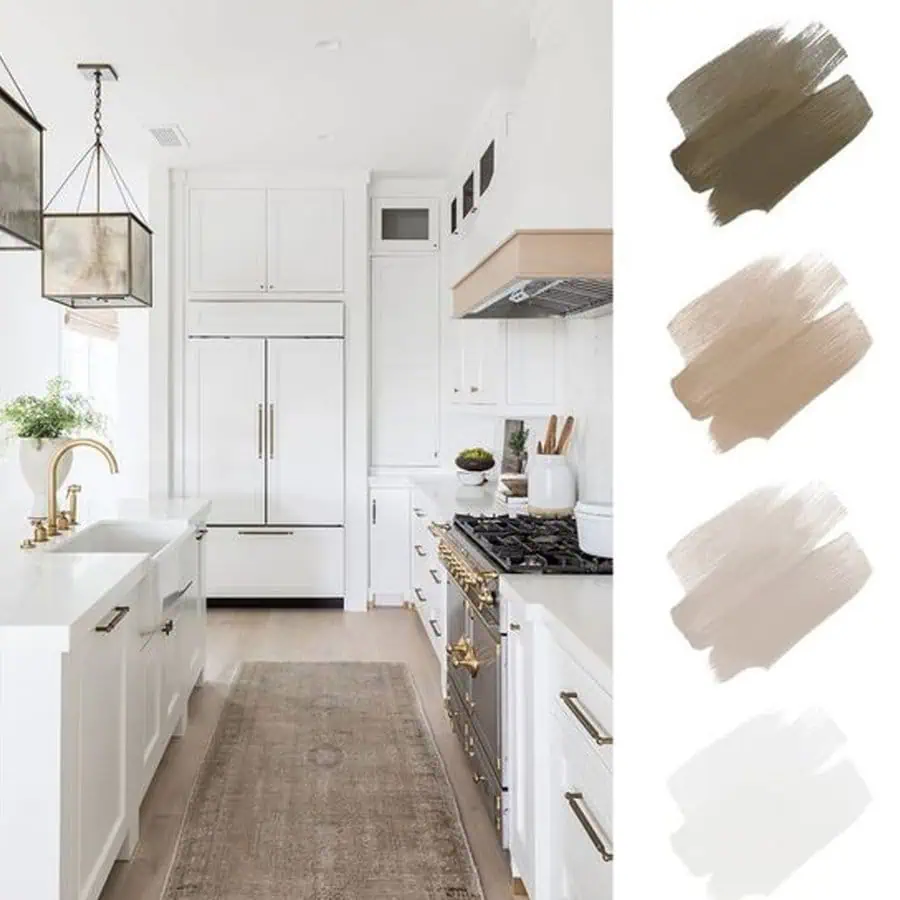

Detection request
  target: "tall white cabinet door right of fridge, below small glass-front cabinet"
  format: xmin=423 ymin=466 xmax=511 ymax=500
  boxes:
xmin=372 ymin=254 xmax=440 ymax=467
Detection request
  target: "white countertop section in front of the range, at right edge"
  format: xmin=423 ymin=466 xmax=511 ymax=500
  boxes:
xmin=500 ymin=575 xmax=613 ymax=694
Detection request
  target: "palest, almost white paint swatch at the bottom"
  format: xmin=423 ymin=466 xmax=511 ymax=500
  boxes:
xmin=669 ymin=711 xmax=872 ymax=900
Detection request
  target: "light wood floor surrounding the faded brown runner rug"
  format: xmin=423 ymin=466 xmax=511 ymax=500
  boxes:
xmin=100 ymin=610 xmax=511 ymax=900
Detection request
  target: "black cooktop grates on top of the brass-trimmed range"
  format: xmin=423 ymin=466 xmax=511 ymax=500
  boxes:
xmin=454 ymin=515 xmax=613 ymax=575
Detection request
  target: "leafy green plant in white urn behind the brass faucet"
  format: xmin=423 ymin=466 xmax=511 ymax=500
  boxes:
xmin=0 ymin=378 xmax=106 ymax=516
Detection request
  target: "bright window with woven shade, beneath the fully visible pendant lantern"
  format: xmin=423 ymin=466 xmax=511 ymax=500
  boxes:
xmin=61 ymin=309 xmax=119 ymax=440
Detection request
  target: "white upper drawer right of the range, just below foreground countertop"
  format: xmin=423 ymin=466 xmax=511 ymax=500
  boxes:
xmin=548 ymin=640 xmax=613 ymax=772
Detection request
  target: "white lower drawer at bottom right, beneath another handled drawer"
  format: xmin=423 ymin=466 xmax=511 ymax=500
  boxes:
xmin=550 ymin=711 xmax=613 ymax=900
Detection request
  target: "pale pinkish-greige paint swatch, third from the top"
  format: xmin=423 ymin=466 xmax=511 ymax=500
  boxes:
xmin=669 ymin=485 xmax=872 ymax=681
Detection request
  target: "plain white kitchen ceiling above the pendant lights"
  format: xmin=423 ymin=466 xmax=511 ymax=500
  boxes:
xmin=0 ymin=0 xmax=533 ymax=174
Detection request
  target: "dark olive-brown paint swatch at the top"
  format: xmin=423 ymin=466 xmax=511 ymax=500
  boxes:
xmin=668 ymin=24 xmax=872 ymax=225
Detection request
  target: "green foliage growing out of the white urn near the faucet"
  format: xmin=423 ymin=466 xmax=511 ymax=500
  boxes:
xmin=0 ymin=377 xmax=106 ymax=447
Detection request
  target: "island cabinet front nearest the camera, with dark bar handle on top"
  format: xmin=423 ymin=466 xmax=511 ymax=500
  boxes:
xmin=69 ymin=604 xmax=134 ymax=898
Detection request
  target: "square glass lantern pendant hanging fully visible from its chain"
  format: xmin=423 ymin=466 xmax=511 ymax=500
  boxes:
xmin=41 ymin=63 xmax=153 ymax=309
